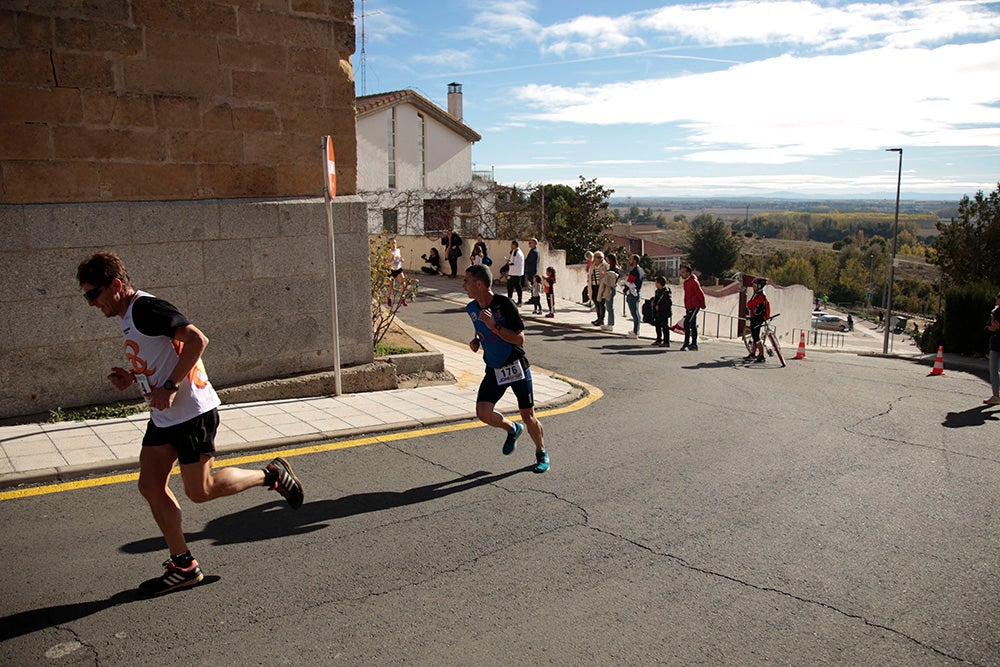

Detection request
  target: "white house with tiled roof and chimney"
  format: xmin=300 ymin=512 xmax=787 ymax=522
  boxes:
xmin=356 ymin=83 xmax=495 ymax=235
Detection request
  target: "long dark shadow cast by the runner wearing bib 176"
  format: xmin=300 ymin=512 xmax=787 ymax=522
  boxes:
xmin=120 ymin=466 xmax=534 ymax=554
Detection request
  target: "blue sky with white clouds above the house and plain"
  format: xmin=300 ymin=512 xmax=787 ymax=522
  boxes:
xmin=353 ymin=0 xmax=1000 ymax=201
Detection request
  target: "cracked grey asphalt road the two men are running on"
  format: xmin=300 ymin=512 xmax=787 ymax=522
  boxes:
xmin=0 ymin=300 xmax=1000 ymax=665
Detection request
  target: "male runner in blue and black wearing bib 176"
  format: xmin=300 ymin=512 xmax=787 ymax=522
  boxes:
xmin=462 ymin=264 xmax=549 ymax=473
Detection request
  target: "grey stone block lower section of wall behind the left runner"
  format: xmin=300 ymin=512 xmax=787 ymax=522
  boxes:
xmin=0 ymin=196 xmax=373 ymax=418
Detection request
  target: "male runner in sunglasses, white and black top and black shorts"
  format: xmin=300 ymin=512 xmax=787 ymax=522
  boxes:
xmin=76 ymin=253 xmax=305 ymax=595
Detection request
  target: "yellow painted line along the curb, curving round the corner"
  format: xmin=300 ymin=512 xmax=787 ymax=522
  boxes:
xmin=0 ymin=368 xmax=604 ymax=501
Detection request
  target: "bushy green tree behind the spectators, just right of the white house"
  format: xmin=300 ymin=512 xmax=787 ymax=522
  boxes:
xmin=545 ymin=176 xmax=614 ymax=264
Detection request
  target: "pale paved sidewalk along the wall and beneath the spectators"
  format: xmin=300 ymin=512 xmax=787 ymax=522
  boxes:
xmin=0 ymin=276 xmax=986 ymax=489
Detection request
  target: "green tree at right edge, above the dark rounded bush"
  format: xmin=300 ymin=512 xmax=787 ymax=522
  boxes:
xmin=933 ymin=183 xmax=1000 ymax=285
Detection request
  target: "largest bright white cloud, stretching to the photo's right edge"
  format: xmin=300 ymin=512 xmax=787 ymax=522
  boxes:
xmin=516 ymin=40 xmax=1000 ymax=164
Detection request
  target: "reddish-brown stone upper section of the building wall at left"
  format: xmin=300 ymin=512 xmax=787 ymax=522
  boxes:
xmin=0 ymin=0 xmax=357 ymax=203
